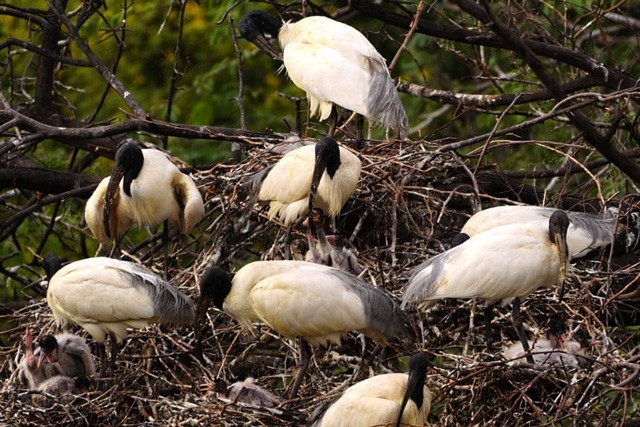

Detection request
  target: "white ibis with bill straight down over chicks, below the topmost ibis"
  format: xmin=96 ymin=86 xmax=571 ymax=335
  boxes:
xmin=249 ymin=137 xmax=362 ymax=226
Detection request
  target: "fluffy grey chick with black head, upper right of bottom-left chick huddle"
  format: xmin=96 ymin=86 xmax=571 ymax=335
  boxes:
xmin=36 ymin=334 xmax=96 ymax=377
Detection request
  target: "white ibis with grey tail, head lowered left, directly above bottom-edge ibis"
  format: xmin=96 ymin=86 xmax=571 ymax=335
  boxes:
xmin=195 ymin=261 xmax=410 ymax=396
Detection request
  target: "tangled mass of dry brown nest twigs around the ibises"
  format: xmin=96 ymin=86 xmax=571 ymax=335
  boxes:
xmin=0 ymin=142 xmax=640 ymax=426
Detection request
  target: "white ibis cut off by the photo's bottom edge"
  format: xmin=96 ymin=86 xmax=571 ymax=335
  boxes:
xmin=312 ymin=353 xmax=431 ymax=427
